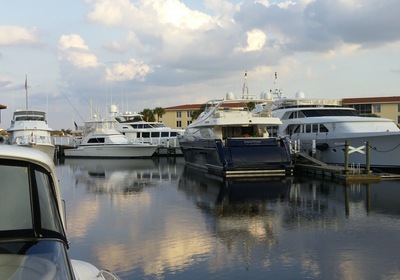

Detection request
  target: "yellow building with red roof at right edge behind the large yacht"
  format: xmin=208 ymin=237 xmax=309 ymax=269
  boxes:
xmin=342 ymin=96 xmax=400 ymax=125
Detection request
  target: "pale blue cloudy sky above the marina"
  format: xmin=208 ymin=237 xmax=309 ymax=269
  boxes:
xmin=0 ymin=0 xmax=400 ymax=129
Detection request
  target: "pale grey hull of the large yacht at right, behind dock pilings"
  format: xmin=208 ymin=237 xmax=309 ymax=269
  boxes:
xmin=291 ymin=132 xmax=400 ymax=170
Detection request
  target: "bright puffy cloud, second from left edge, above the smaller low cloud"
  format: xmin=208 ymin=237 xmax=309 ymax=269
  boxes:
xmin=58 ymin=34 xmax=99 ymax=68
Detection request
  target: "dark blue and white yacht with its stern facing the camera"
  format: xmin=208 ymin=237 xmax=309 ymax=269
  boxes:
xmin=179 ymin=72 xmax=293 ymax=177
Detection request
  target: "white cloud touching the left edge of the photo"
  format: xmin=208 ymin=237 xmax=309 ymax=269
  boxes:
xmin=0 ymin=25 xmax=40 ymax=46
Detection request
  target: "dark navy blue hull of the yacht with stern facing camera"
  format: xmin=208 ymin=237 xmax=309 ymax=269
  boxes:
xmin=180 ymin=138 xmax=293 ymax=177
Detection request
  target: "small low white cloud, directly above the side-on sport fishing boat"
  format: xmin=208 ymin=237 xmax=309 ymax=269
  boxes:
xmin=106 ymin=59 xmax=153 ymax=81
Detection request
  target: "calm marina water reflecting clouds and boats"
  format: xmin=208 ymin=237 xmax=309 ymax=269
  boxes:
xmin=57 ymin=158 xmax=400 ymax=279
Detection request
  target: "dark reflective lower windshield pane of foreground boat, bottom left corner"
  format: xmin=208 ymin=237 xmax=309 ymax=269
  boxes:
xmin=0 ymin=239 xmax=73 ymax=280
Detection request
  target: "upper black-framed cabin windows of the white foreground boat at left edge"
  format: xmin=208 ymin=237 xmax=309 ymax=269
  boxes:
xmin=0 ymin=159 xmax=66 ymax=242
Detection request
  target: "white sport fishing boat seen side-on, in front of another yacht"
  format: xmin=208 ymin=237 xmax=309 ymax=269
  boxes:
xmin=64 ymin=120 xmax=158 ymax=158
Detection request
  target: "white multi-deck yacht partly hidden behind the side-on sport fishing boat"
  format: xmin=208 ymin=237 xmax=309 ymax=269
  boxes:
xmin=110 ymin=105 xmax=184 ymax=154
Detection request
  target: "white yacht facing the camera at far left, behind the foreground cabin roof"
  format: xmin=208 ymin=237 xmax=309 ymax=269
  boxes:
xmin=7 ymin=110 xmax=55 ymax=158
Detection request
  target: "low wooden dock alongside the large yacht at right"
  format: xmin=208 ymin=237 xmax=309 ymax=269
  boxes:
xmin=294 ymin=153 xmax=400 ymax=183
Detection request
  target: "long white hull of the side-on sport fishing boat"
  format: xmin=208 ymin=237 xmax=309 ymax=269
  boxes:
xmin=64 ymin=145 xmax=157 ymax=158
